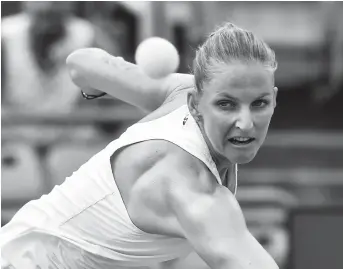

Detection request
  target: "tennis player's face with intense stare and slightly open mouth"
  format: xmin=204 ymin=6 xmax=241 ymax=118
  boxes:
xmin=190 ymin=63 xmax=277 ymax=163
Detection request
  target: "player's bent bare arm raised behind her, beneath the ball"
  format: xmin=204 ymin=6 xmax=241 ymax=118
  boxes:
xmin=67 ymin=48 xmax=193 ymax=112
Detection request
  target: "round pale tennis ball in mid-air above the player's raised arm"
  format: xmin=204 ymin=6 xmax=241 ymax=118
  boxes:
xmin=135 ymin=37 xmax=180 ymax=79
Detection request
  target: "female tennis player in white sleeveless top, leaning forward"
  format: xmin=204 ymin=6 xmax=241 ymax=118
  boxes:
xmin=0 ymin=23 xmax=278 ymax=269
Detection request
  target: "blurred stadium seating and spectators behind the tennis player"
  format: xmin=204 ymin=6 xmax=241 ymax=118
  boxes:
xmin=1 ymin=1 xmax=343 ymax=269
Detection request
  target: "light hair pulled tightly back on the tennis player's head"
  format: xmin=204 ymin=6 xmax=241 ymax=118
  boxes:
xmin=193 ymin=23 xmax=277 ymax=93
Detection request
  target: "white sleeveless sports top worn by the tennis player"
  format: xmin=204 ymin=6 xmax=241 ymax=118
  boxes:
xmin=0 ymin=106 xmax=237 ymax=269
